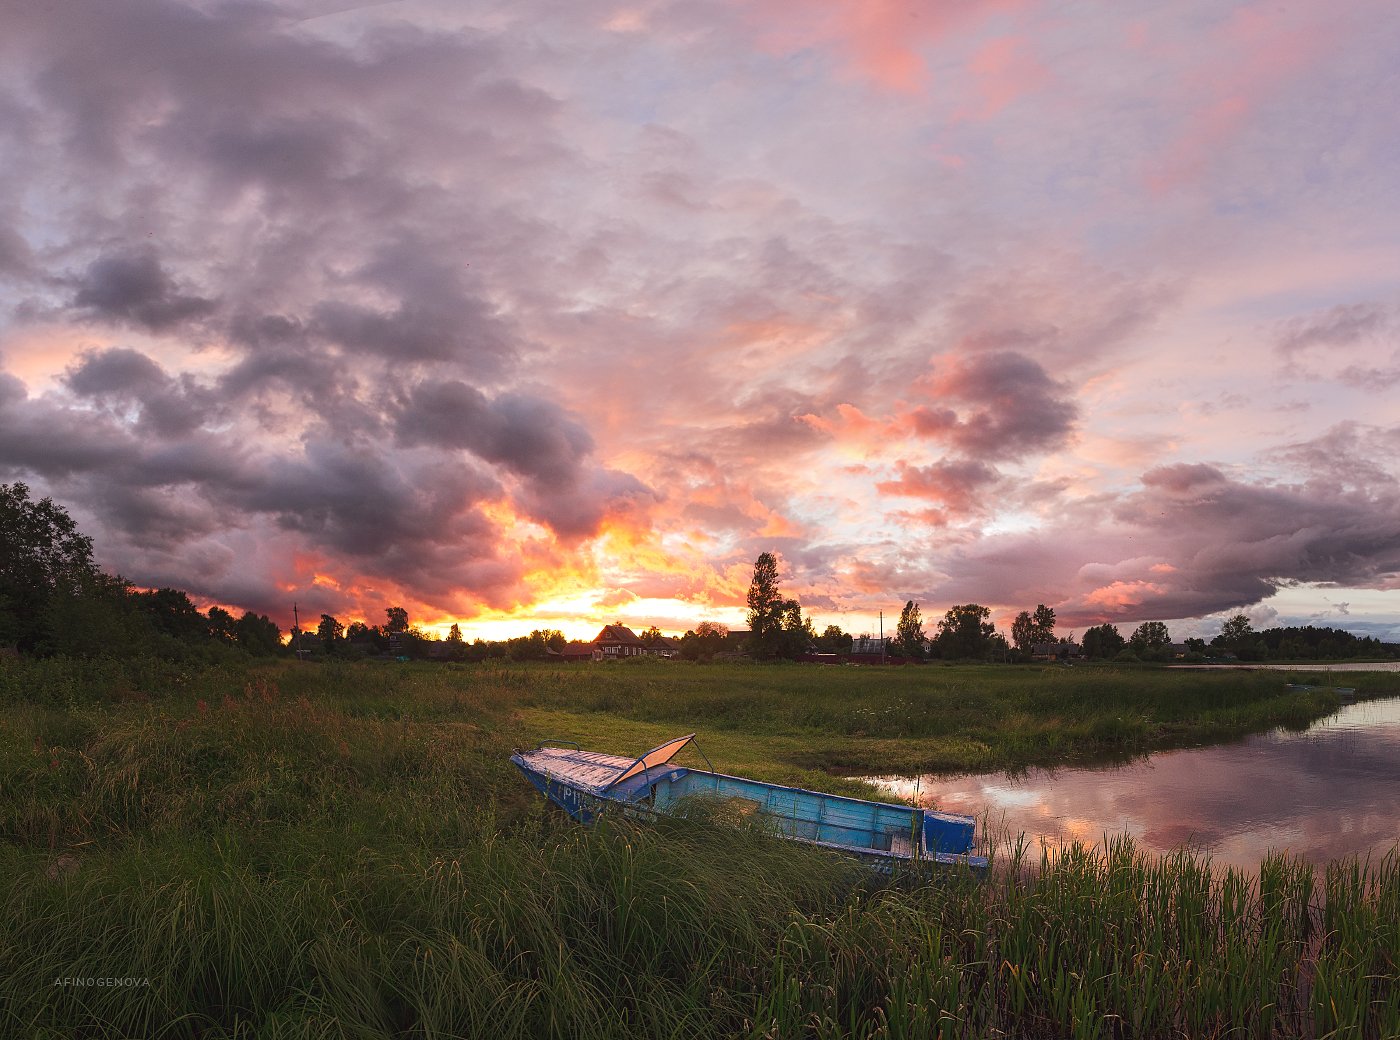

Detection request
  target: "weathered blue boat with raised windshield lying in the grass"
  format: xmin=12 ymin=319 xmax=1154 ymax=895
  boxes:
xmin=511 ymin=733 xmax=987 ymax=872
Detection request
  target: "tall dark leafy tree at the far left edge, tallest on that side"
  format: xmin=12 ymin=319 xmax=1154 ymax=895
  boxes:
xmin=0 ymin=483 xmax=99 ymax=652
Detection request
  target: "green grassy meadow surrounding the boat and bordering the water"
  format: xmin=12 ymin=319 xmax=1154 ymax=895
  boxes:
xmin=0 ymin=659 xmax=1400 ymax=1040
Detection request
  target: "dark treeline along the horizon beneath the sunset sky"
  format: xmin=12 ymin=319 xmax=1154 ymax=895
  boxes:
xmin=0 ymin=483 xmax=1400 ymax=663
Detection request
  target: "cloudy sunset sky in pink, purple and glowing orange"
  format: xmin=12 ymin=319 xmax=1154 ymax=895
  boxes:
xmin=0 ymin=0 xmax=1400 ymax=640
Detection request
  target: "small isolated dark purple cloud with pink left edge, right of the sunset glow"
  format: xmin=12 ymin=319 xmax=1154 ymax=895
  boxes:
xmin=910 ymin=350 xmax=1079 ymax=459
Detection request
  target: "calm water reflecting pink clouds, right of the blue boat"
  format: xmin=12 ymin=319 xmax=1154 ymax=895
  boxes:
xmin=872 ymin=697 xmax=1400 ymax=869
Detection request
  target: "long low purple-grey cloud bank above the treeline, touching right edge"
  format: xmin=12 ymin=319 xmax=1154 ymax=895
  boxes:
xmin=939 ymin=463 xmax=1400 ymax=626
